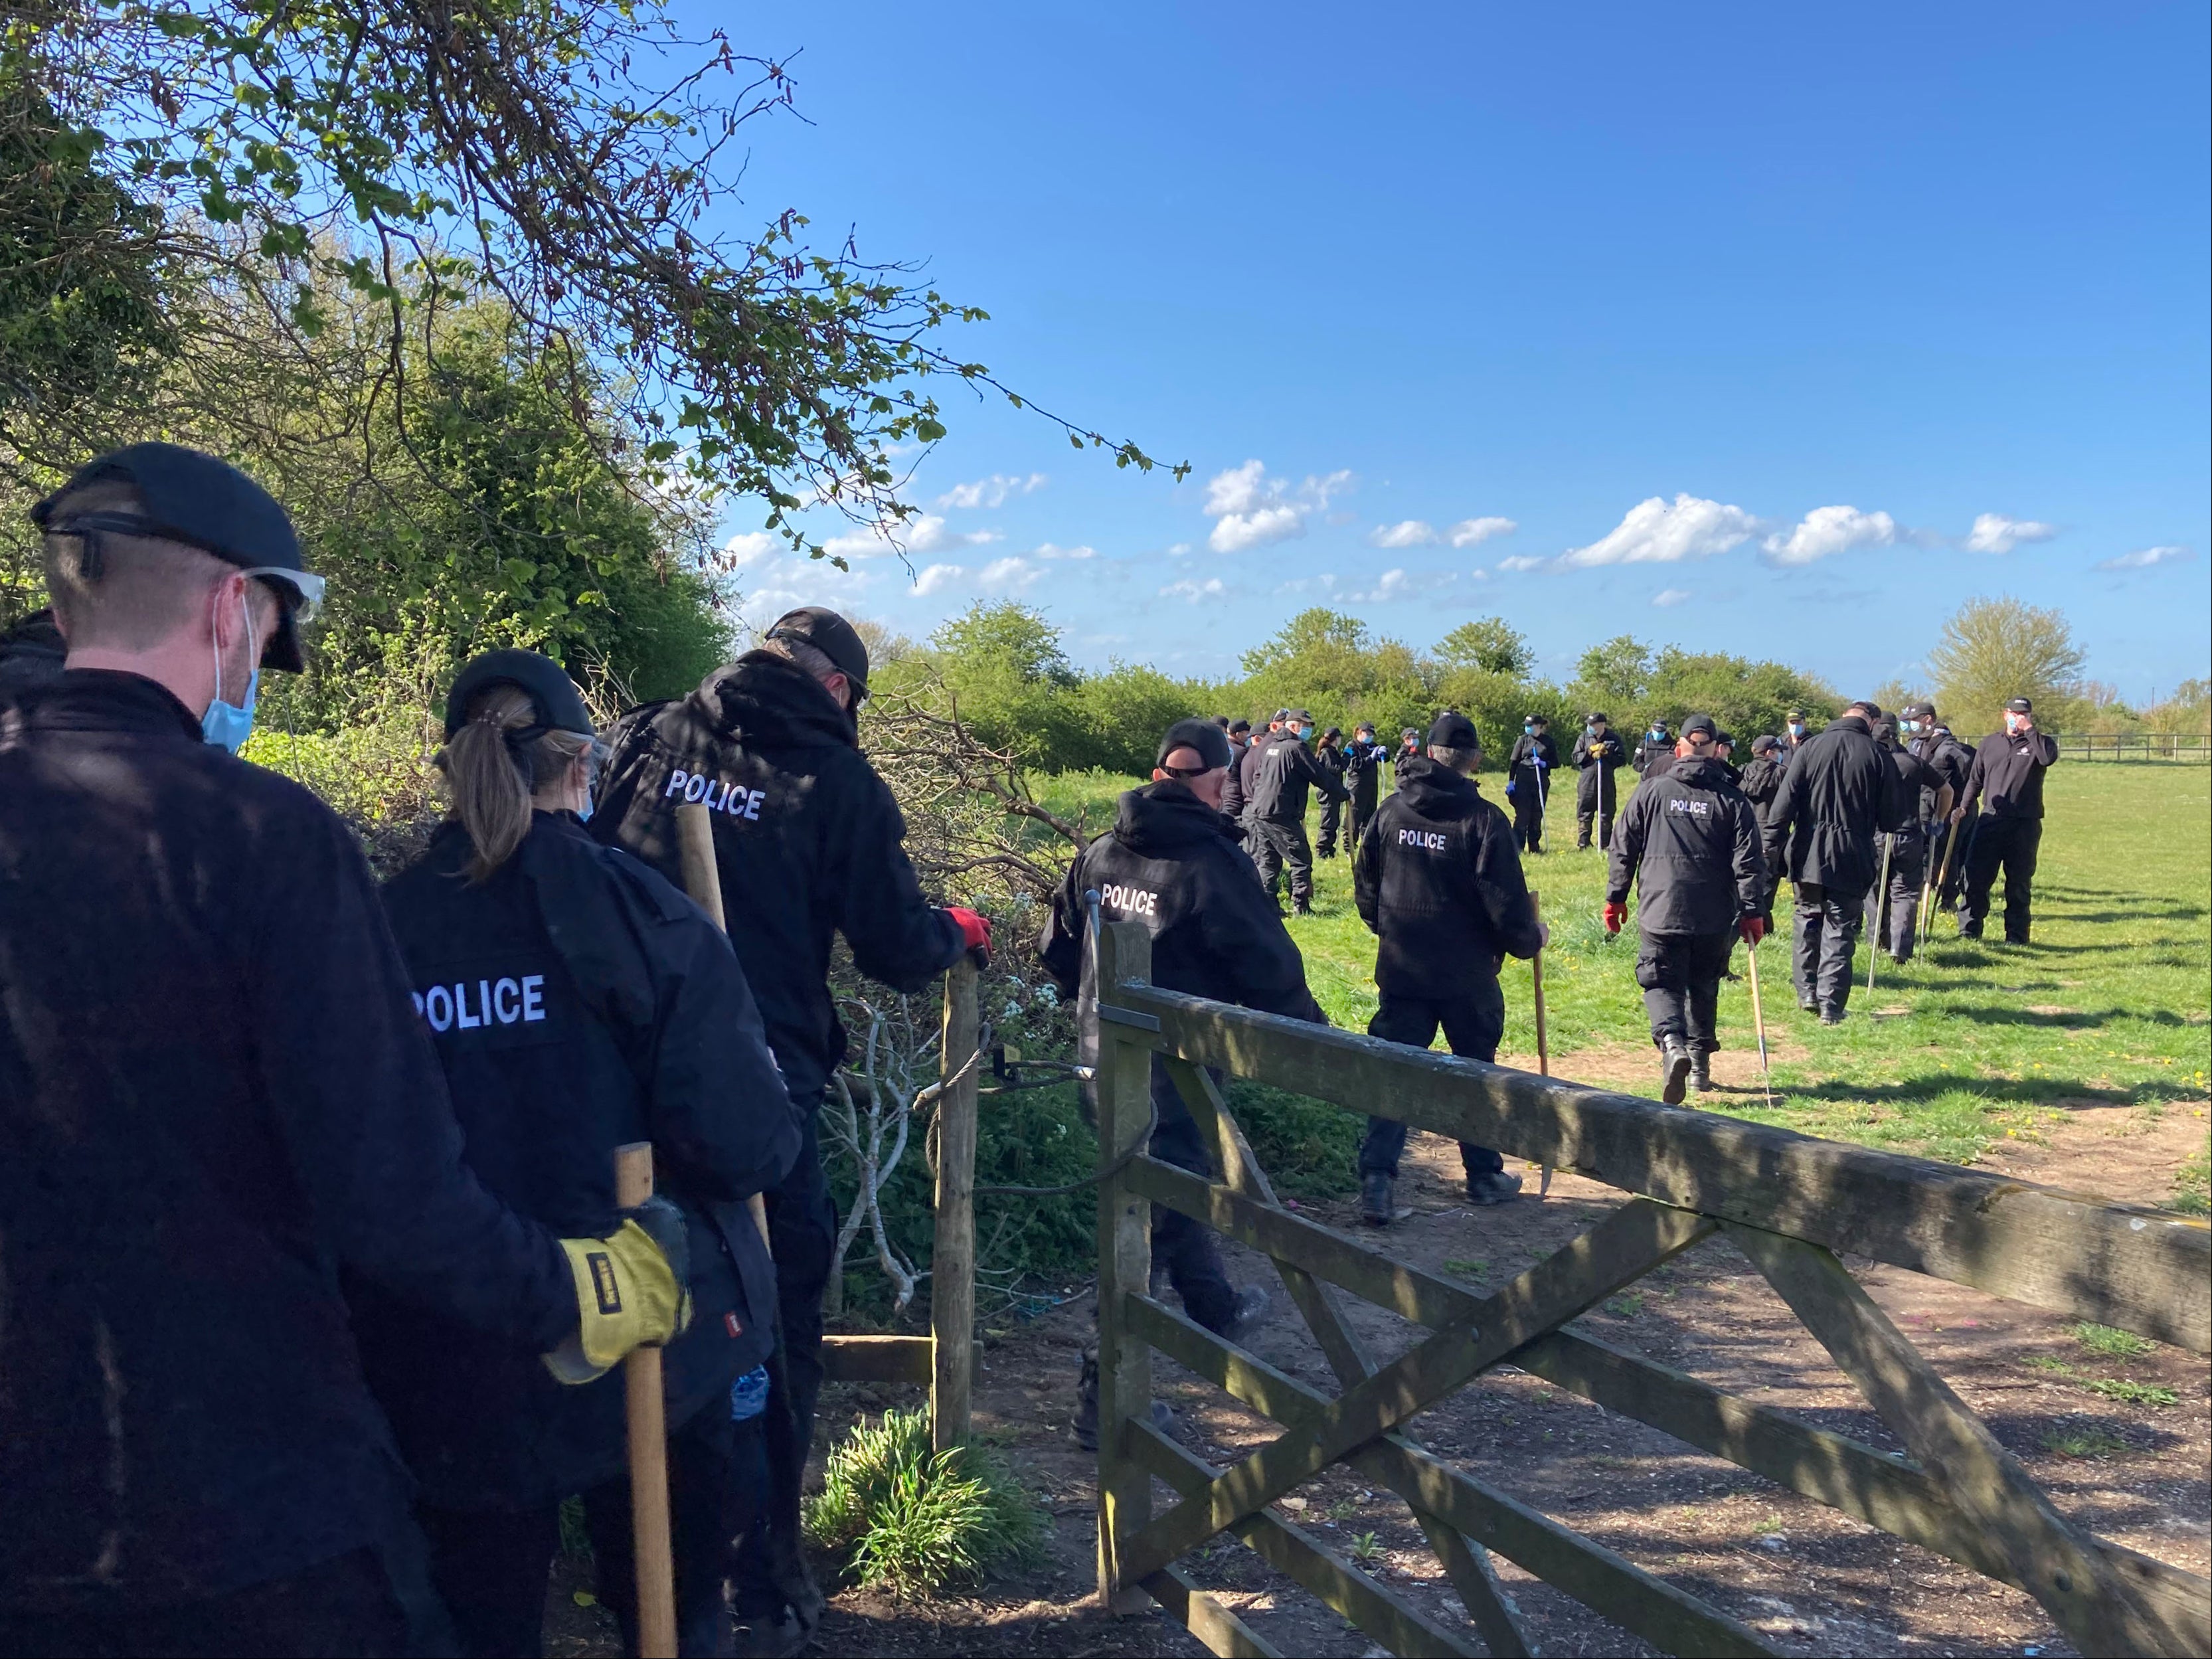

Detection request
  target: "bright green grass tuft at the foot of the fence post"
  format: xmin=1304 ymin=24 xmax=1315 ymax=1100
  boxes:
xmin=805 ymin=1409 xmax=1047 ymax=1599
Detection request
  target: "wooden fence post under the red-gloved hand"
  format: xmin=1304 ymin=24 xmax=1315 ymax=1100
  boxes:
xmin=929 ymin=956 xmax=980 ymax=1451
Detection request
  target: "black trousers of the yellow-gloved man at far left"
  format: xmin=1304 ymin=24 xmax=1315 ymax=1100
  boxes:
xmin=0 ymin=1548 xmax=411 ymax=1659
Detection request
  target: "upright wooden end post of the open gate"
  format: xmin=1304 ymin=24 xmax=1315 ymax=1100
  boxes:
xmin=1097 ymin=922 xmax=1152 ymax=1613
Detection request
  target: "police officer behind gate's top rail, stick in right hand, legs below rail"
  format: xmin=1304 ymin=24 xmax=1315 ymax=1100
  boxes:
xmin=1351 ymin=712 xmax=1551 ymax=1228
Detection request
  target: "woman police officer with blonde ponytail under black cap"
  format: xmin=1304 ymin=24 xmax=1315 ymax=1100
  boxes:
xmin=354 ymin=650 xmax=801 ymax=1654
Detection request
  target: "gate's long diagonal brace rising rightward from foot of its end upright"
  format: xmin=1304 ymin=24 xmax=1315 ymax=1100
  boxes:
xmin=1119 ymin=1194 xmax=1715 ymax=1581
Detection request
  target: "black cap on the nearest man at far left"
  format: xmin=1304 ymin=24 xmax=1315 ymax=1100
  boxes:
xmin=31 ymin=442 xmax=307 ymax=675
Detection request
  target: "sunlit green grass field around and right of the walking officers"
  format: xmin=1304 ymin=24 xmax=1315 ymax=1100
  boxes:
xmin=1040 ymin=763 xmax=2212 ymax=1162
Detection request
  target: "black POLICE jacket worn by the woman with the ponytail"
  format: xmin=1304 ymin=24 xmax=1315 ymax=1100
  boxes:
xmin=354 ymin=812 xmax=801 ymax=1509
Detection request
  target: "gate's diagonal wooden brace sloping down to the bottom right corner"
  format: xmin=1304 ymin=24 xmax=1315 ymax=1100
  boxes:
xmin=1728 ymin=1223 xmax=2170 ymax=1654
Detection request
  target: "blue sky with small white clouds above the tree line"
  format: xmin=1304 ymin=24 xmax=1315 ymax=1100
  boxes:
xmin=688 ymin=2 xmax=2212 ymax=699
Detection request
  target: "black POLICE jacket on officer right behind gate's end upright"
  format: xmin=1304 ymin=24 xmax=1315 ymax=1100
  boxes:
xmin=1037 ymin=778 xmax=1325 ymax=1039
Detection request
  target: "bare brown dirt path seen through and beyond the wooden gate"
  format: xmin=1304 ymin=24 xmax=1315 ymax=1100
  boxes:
xmin=555 ymin=1106 xmax=2212 ymax=1659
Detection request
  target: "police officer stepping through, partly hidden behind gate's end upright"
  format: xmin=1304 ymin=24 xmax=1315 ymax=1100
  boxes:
xmin=1037 ymin=721 xmax=1325 ymax=1449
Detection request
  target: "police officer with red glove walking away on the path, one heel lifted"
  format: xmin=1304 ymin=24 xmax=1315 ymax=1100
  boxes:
xmin=1606 ymin=715 xmax=1770 ymax=1106
